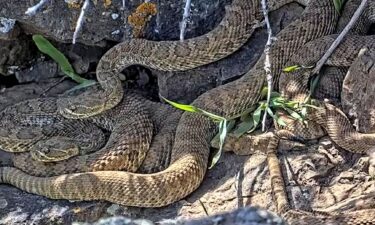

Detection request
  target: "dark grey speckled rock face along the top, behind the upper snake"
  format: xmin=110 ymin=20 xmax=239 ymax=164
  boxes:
xmin=0 ymin=0 xmax=234 ymax=45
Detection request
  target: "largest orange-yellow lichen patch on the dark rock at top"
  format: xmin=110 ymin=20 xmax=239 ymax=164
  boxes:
xmin=128 ymin=2 xmax=157 ymax=38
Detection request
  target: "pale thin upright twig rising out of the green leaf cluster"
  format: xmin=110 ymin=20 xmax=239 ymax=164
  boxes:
xmin=262 ymin=0 xmax=272 ymax=131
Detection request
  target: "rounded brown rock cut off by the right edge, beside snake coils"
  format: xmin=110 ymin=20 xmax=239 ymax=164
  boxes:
xmin=341 ymin=50 xmax=375 ymax=133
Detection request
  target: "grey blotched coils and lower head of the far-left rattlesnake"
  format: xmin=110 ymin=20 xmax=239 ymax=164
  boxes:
xmin=0 ymin=98 xmax=105 ymax=162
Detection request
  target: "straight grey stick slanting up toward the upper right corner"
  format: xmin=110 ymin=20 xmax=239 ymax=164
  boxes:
xmin=312 ymin=0 xmax=367 ymax=74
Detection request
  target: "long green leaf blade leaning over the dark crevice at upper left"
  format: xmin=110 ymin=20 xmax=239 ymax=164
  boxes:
xmin=33 ymin=34 xmax=89 ymax=84
